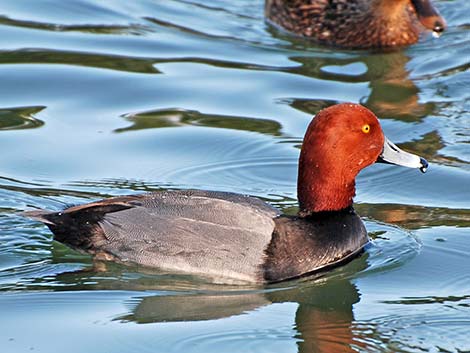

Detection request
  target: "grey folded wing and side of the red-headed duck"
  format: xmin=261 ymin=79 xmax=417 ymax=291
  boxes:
xmin=99 ymin=191 xmax=279 ymax=282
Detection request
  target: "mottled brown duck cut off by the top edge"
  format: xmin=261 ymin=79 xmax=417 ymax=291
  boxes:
xmin=265 ymin=0 xmax=446 ymax=49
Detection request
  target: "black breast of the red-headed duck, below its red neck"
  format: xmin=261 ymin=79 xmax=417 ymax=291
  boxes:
xmin=264 ymin=209 xmax=369 ymax=282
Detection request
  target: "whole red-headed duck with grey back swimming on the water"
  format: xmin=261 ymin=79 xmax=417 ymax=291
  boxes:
xmin=25 ymin=103 xmax=428 ymax=283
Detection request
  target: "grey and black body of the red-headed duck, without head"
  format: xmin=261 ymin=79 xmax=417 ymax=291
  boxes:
xmin=30 ymin=190 xmax=368 ymax=283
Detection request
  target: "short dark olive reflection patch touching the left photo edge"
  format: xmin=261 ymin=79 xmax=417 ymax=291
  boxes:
xmin=0 ymin=106 xmax=46 ymax=131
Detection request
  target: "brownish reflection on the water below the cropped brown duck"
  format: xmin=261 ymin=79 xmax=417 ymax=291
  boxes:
xmin=290 ymin=51 xmax=435 ymax=122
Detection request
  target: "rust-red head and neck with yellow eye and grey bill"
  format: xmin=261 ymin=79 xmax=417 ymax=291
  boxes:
xmin=297 ymin=103 xmax=427 ymax=215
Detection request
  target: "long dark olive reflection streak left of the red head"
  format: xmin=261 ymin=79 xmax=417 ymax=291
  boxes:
xmin=114 ymin=109 xmax=282 ymax=136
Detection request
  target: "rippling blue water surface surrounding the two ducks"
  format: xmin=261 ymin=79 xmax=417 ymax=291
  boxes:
xmin=0 ymin=0 xmax=470 ymax=353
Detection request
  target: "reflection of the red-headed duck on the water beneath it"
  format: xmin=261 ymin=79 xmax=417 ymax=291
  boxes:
xmin=117 ymin=256 xmax=366 ymax=353
